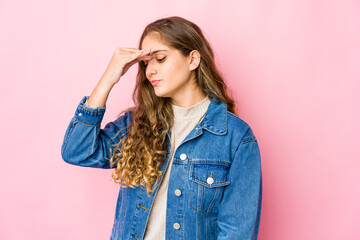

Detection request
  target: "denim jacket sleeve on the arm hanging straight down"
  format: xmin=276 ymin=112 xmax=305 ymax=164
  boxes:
xmin=218 ymin=129 xmax=262 ymax=240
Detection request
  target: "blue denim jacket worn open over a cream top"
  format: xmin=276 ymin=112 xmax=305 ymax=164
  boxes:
xmin=61 ymin=96 xmax=262 ymax=240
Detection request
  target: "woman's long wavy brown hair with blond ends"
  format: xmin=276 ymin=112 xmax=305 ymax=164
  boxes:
xmin=110 ymin=16 xmax=236 ymax=195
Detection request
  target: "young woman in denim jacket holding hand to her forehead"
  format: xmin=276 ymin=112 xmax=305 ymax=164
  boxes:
xmin=61 ymin=17 xmax=262 ymax=240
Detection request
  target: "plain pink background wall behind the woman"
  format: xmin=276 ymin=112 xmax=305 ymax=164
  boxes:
xmin=0 ymin=0 xmax=360 ymax=240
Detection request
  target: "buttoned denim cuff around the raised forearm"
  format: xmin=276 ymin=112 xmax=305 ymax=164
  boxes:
xmin=75 ymin=96 xmax=106 ymax=126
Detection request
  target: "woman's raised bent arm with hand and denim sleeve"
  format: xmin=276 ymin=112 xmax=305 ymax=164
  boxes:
xmin=61 ymin=48 xmax=152 ymax=168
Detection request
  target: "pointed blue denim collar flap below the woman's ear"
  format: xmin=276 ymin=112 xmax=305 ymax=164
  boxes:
xmin=201 ymin=96 xmax=227 ymax=135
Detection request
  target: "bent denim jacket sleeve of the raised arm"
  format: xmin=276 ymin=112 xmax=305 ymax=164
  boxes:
xmin=61 ymin=96 xmax=131 ymax=168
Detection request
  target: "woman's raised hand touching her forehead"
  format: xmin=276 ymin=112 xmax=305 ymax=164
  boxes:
xmin=102 ymin=48 xmax=152 ymax=86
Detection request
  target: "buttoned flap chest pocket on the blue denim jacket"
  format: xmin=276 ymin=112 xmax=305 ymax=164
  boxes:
xmin=189 ymin=162 xmax=230 ymax=212
